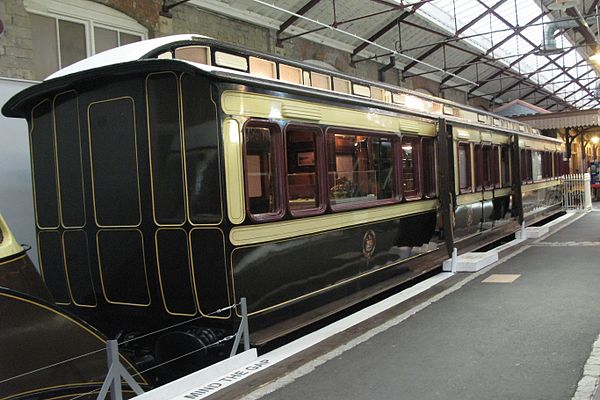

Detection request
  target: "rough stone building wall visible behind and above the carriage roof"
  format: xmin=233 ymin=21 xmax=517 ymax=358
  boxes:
xmin=0 ymin=0 xmax=484 ymax=105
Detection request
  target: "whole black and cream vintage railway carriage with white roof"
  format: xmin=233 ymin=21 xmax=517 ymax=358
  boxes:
xmin=3 ymin=35 xmax=561 ymax=390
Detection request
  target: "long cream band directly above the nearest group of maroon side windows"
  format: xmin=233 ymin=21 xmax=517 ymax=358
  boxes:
xmin=221 ymin=90 xmax=437 ymax=136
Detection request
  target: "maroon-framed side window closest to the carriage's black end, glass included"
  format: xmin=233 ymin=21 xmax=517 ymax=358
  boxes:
xmin=244 ymin=122 xmax=283 ymax=220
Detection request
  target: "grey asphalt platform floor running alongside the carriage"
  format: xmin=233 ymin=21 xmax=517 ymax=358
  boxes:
xmin=209 ymin=212 xmax=600 ymax=400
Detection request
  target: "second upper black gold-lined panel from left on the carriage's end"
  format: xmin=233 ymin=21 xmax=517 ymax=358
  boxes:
xmin=54 ymin=92 xmax=85 ymax=227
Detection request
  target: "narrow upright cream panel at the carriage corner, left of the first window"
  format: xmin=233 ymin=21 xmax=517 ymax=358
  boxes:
xmin=223 ymin=118 xmax=246 ymax=225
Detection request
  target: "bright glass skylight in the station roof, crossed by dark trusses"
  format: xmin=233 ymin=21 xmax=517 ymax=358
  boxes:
xmin=412 ymin=0 xmax=598 ymax=108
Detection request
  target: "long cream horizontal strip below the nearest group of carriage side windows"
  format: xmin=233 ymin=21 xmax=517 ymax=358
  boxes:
xmin=229 ymin=199 xmax=437 ymax=246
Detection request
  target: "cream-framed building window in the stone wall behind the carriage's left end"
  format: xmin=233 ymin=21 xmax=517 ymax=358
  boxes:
xmin=24 ymin=0 xmax=148 ymax=80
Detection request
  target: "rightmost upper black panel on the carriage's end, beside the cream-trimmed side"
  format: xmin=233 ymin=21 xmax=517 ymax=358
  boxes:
xmin=181 ymin=74 xmax=223 ymax=224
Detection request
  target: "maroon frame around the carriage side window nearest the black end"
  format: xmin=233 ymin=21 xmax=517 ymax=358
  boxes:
xmin=242 ymin=118 xmax=287 ymax=222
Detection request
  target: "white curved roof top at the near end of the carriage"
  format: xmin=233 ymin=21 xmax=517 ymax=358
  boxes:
xmin=44 ymin=34 xmax=204 ymax=81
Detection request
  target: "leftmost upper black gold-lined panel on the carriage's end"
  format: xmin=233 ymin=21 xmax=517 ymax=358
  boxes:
xmin=30 ymin=101 xmax=59 ymax=228
